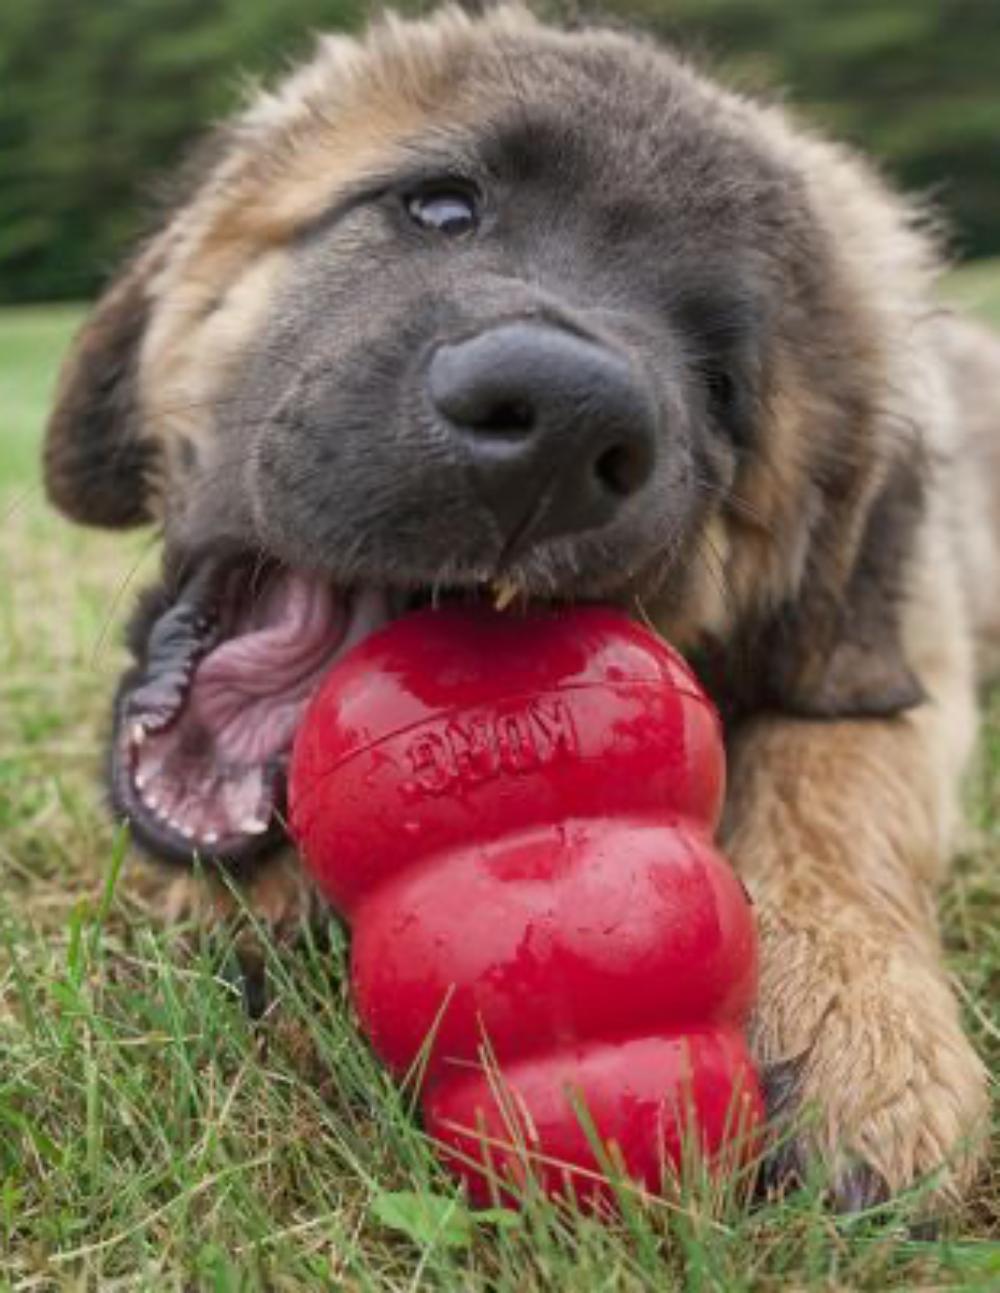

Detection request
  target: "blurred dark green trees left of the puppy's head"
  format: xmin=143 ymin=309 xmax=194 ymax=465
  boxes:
xmin=0 ymin=0 xmax=364 ymax=301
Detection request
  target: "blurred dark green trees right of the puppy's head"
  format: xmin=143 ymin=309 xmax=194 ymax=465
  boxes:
xmin=620 ymin=0 xmax=1000 ymax=256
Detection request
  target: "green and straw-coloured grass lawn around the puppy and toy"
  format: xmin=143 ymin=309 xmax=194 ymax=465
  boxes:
xmin=0 ymin=264 xmax=1000 ymax=1290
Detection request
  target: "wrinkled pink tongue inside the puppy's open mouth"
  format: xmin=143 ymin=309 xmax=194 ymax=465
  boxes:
xmin=185 ymin=573 xmax=389 ymax=764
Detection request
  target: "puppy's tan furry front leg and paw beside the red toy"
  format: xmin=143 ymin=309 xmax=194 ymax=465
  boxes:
xmin=726 ymin=705 xmax=986 ymax=1209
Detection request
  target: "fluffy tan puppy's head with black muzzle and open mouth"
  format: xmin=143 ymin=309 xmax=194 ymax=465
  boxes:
xmin=47 ymin=9 xmax=915 ymax=862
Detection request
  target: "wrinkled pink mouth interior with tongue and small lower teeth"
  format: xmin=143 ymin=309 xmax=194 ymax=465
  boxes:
xmin=124 ymin=572 xmax=389 ymax=853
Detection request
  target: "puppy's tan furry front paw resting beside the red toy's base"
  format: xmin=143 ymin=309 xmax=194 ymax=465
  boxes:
xmin=754 ymin=915 xmax=986 ymax=1212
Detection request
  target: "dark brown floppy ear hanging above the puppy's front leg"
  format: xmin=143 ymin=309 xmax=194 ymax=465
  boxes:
xmin=765 ymin=453 xmax=925 ymax=718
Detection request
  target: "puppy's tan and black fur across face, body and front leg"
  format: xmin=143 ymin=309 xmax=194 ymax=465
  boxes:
xmin=45 ymin=8 xmax=1000 ymax=1206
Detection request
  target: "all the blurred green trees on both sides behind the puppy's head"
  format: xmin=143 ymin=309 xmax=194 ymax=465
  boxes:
xmin=0 ymin=0 xmax=1000 ymax=301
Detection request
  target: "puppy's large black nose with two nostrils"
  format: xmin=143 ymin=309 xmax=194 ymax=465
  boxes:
xmin=428 ymin=322 xmax=656 ymax=540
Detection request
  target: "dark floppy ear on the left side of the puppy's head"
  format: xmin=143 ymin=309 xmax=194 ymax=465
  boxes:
xmin=44 ymin=244 xmax=159 ymax=528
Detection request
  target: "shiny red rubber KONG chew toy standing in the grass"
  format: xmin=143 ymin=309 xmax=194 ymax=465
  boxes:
xmin=290 ymin=608 xmax=763 ymax=1202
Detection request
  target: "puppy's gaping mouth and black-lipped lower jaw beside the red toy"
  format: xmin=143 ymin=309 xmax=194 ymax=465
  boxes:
xmin=110 ymin=556 xmax=654 ymax=871
